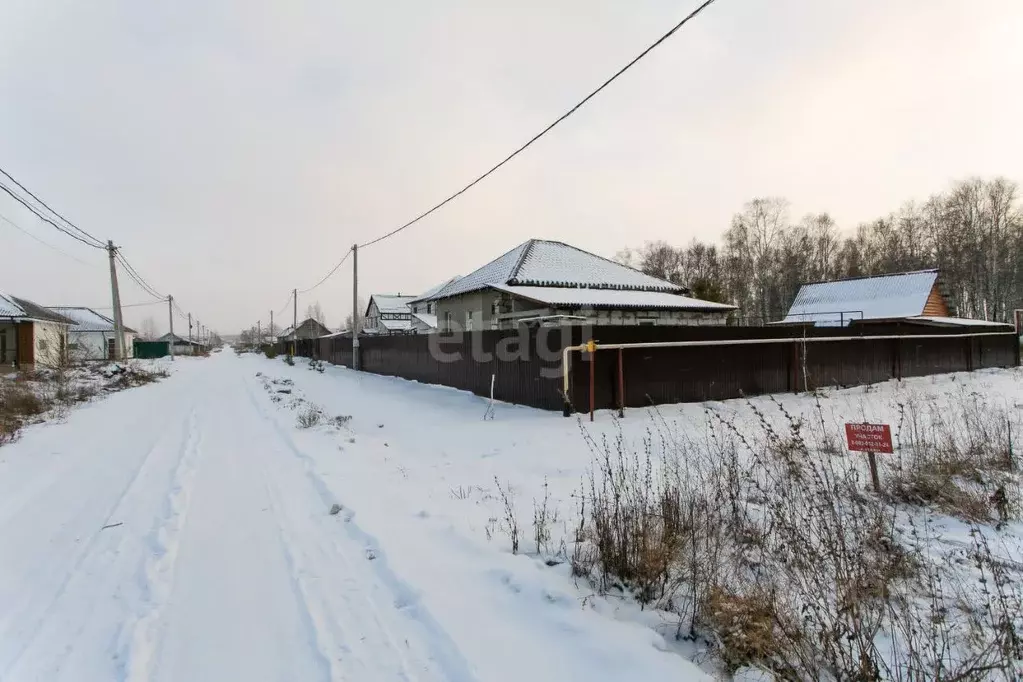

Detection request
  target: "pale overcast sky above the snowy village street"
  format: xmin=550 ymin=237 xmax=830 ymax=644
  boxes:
xmin=0 ymin=0 xmax=1023 ymax=333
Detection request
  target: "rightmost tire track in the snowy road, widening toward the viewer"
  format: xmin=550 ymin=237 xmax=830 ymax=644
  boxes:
xmin=247 ymin=384 xmax=476 ymax=682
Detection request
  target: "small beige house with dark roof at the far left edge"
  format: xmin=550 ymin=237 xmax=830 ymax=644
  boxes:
xmin=0 ymin=293 xmax=74 ymax=369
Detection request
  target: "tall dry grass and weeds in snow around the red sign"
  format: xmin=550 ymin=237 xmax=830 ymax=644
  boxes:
xmin=573 ymin=388 xmax=1023 ymax=682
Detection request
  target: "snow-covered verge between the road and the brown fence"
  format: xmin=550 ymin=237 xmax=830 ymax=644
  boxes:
xmin=252 ymin=361 xmax=1023 ymax=679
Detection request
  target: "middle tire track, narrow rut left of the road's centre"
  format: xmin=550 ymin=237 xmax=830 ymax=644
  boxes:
xmin=120 ymin=408 xmax=203 ymax=682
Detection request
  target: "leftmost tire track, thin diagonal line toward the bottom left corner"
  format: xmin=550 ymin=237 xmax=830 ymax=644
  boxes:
xmin=0 ymin=411 xmax=195 ymax=679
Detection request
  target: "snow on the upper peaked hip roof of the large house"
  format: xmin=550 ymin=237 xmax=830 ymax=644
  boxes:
xmin=433 ymin=239 xmax=684 ymax=299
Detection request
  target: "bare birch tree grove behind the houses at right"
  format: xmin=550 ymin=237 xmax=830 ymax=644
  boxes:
xmin=617 ymin=178 xmax=1023 ymax=323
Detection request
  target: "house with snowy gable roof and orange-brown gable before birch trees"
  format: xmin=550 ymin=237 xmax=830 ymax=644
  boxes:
xmin=781 ymin=270 xmax=962 ymax=326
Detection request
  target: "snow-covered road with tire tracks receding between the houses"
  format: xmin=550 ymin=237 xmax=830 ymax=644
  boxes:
xmin=0 ymin=352 xmax=703 ymax=682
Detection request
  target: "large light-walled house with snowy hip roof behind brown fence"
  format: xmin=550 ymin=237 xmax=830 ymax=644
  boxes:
xmin=413 ymin=239 xmax=736 ymax=331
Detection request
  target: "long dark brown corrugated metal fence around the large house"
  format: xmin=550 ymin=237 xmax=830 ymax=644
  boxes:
xmin=284 ymin=324 xmax=1019 ymax=411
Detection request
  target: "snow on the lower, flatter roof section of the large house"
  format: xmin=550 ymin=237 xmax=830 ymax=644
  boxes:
xmin=494 ymin=285 xmax=736 ymax=312
